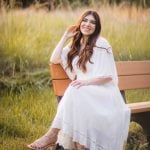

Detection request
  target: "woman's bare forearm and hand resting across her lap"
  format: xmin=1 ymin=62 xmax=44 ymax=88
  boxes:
xmin=70 ymin=77 xmax=112 ymax=88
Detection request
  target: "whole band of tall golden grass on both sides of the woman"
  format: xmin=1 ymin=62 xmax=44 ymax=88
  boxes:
xmin=0 ymin=6 xmax=150 ymax=74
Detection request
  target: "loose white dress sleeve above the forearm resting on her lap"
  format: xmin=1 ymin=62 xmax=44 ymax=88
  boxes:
xmin=93 ymin=47 xmax=118 ymax=84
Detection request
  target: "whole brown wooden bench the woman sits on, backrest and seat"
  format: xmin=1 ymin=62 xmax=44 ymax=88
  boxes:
xmin=50 ymin=61 xmax=150 ymax=135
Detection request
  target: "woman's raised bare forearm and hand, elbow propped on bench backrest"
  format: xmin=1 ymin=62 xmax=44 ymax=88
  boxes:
xmin=50 ymin=26 xmax=77 ymax=64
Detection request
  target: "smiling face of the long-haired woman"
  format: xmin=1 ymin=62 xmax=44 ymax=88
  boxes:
xmin=80 ymin=15 xmax=96 ymax=36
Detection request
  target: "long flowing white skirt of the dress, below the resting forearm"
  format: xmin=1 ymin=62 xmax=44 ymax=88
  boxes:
xmin=52 ymin=85 xmax=130 ymax=150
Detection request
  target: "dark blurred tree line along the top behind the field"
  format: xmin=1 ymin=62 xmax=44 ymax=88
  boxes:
xmin=0 ymin=0 xmax=150 ymax=10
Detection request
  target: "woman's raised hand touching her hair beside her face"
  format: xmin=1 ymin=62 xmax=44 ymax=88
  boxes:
xmin=63 ymin=25 xmax=79 ymax=40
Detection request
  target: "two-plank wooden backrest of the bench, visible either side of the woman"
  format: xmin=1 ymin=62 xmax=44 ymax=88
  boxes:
xmin=50 ymin=61 xmax=150 ymax=96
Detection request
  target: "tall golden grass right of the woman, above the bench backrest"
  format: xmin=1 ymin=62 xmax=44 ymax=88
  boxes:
xmin=102 ymin=7 xmax=150 ymax=60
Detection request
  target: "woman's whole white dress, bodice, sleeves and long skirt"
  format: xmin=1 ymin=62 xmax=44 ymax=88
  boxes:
xmin=52 ymin=37 xmax=130 ymax=150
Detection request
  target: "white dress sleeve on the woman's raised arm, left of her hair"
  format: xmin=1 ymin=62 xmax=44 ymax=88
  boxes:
xmin=61 ymin=45 xmax=76 ymax=80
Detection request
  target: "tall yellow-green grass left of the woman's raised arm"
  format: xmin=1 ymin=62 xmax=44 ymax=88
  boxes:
xmin=0 ymin=10 xmax=73 ymax=72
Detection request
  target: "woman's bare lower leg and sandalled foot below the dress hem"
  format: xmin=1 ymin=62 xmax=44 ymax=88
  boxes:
xmin=28 ymin=128 xmax=59 ymax=150
